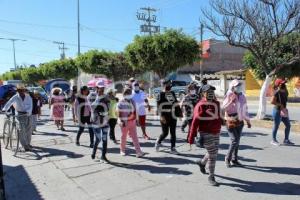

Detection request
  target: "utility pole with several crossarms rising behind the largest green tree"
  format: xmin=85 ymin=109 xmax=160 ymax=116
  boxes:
xmin=136 ymin=7 xmax=160 ymax=96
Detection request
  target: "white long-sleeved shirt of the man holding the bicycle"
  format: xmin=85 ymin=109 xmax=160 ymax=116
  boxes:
xmin=2 ymin=94 xmax=32 ymax=115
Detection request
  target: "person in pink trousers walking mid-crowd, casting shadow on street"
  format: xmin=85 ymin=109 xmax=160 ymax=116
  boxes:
xmin=118 ymin=88 xmax=145 ymax=158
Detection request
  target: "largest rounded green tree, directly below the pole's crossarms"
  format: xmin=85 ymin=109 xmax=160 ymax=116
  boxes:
xmin=125 ymin=30 xmax=199 ymax=78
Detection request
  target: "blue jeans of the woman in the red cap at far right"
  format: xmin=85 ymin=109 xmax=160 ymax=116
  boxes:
xmin=272 ymin=108 xmax=291 ymax=141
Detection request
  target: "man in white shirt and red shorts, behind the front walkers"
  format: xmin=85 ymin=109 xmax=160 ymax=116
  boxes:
xmin=132 ymin=82 xmax=150 ymax=140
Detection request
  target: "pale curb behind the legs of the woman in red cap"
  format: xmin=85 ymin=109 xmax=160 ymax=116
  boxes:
xmin=251 ymin=119 xmax=300 ymax=134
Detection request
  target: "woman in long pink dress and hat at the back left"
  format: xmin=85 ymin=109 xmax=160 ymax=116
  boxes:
xmin=50 ymin=88 xmax=65 ymax=131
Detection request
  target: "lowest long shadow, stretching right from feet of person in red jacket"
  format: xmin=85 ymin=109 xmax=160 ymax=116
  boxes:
xmin=216 ymin=175 xmax=300 ymax=195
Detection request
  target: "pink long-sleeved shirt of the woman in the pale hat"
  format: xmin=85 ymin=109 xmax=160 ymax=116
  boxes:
xmin=223 ymin=91 xmax=250 ymax=120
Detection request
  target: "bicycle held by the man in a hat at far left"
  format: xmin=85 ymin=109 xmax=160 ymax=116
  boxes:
xmin=2 ymin=113 xmax=20 ymax=155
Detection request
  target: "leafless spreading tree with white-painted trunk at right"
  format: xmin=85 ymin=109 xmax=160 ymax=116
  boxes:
xmin=202 ymin=0 xmax=300 ymax=119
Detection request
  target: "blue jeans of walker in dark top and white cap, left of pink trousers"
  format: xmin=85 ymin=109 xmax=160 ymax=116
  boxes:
xmin=92 ymin=126 xmax=108 ymax=157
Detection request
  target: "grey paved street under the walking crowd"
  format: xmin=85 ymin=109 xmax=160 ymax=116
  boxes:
xmin=2 ymin=108 xmax=300 ymax=200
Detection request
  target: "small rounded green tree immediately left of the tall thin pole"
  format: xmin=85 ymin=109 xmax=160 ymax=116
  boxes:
xmin=40 ymin=59 xmax=78 ymax=80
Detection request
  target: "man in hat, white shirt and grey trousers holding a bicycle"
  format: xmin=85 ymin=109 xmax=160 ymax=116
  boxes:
xmin=2 ymin=85 xmax=32 ymax=151
